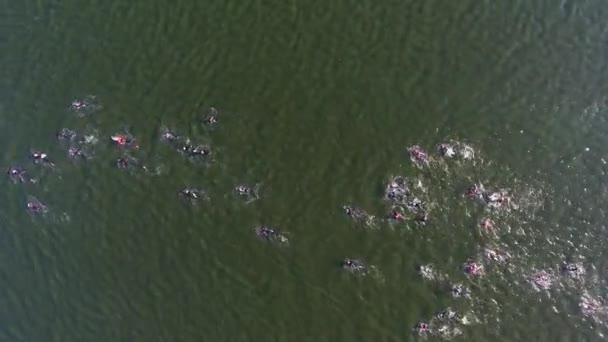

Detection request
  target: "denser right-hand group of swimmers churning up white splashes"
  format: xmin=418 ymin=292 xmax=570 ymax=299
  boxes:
xmin=334 ymin=141 xmax=601 ymax=338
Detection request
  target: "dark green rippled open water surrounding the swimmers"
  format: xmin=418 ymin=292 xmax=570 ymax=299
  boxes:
xmin=0 ymin=0 xmax=608 ymax=342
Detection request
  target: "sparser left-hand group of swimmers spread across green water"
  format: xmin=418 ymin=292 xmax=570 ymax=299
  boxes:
xmin=7 ymin=95 xmax=258 ymax=216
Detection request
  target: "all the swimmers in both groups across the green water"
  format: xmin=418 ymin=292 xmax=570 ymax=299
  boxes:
xmin=7 ymin=96 xmax=602 ymax=335
